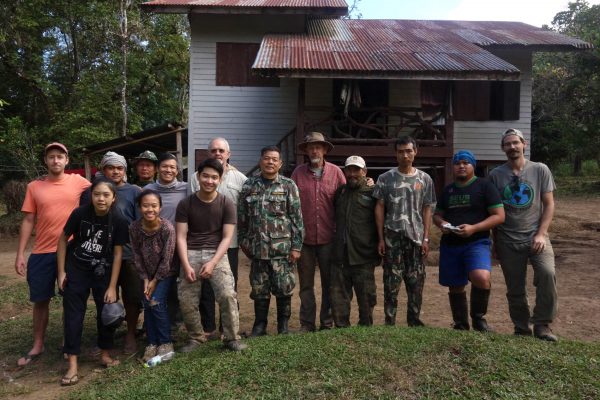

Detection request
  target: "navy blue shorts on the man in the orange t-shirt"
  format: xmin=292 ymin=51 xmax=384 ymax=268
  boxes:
xmin=27 ymin=253 xmax=57 ymax=303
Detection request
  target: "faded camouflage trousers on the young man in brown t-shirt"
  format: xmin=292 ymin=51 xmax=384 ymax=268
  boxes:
xmin=177 ymin=250 xmax=240 ymax=342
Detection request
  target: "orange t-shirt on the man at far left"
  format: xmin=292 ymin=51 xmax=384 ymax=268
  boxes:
xmin=21 ymin=174 xmax=90 ymax=254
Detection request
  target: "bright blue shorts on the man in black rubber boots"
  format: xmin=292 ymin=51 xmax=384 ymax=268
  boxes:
xmin=440 ymin=239 xmax=492 ymax=286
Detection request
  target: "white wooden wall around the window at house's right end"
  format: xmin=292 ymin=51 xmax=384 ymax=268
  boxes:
xmin=454 ymin=51 xmax=533 ymax=161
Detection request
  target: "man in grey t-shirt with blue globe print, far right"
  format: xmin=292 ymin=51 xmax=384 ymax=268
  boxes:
xmin=490 ymin=129 xmax=558 ymax=342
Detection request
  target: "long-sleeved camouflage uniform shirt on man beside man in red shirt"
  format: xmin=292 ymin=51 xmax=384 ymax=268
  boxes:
xmin=238 ymin=175 xmax=304 ymax=260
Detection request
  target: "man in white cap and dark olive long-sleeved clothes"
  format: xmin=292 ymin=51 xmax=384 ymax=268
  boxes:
xmin=331 ymin=156 xmax=381 ymax=328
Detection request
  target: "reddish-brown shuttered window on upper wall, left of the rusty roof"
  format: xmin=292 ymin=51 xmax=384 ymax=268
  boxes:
xmin=216 ymin=43 xmax=279 ymax=87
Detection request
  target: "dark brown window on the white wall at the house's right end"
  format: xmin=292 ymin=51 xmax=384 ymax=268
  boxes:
xmin=453 ymin=81 xmax=521 ymax=121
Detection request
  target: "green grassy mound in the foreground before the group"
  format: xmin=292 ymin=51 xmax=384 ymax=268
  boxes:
xmin=70 ymin=326 xmax=600 ymax=399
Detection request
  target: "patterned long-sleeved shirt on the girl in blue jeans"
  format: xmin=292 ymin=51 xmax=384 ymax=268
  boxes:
xmin=129 ymin=218 xmax=176 ymax=281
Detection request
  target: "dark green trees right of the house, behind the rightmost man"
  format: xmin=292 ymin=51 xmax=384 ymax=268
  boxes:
xmin=532 ymin=0 xmax=600 ymax=173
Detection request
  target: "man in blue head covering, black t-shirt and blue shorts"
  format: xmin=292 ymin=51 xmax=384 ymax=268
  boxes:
xmin=433 ymin=150 xmax=504 ymax=332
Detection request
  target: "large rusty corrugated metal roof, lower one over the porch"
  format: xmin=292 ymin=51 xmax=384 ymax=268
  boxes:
xmin=253 ymin=19 xmax=591 ymax=79
